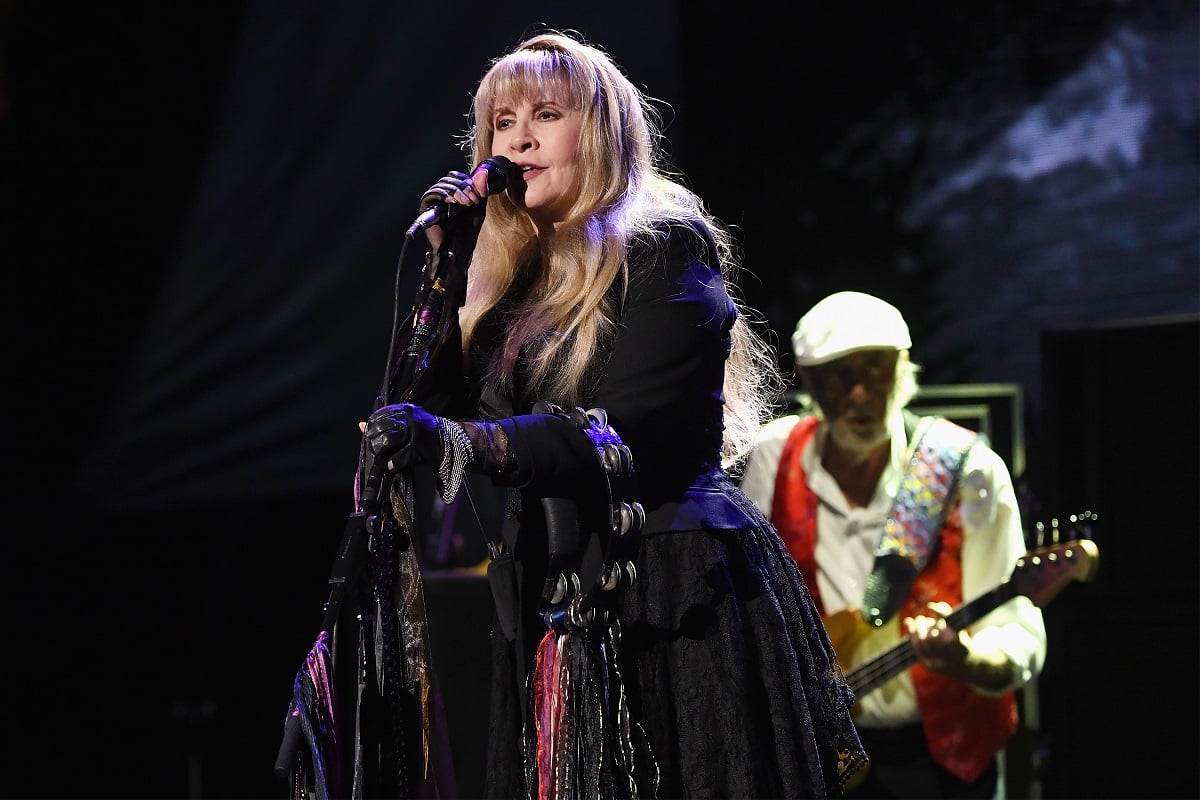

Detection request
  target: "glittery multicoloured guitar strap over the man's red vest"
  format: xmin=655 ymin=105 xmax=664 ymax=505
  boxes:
xmin=863 ymin=410 xmax=980 ymax=627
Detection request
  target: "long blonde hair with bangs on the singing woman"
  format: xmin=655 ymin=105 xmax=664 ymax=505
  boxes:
xmin=461 ymin=31 xmax=782 ymax=467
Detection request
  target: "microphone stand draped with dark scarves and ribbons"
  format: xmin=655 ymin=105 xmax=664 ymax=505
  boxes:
xmin=274 ymin=201 xmax=484 ymax=799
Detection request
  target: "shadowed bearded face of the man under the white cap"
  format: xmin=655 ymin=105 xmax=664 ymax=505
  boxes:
xmin=797 ymin=348 xmax=900 ymax=453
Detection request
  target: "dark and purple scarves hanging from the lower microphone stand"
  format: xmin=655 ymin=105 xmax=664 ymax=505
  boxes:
xmin=276 ymin=491 xmax=454 ymax=800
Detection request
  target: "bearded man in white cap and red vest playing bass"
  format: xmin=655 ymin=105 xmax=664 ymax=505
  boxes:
xmin=742 ymin=291 xmax=1045 ymax=798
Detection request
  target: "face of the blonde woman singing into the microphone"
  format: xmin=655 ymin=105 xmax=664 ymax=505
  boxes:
xmin=492 ymin=98 xmax=583 ymax=228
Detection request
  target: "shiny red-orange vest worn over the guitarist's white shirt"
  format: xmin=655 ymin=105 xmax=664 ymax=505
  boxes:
xmin=770 ymin=416 xmax=1016 ymax=782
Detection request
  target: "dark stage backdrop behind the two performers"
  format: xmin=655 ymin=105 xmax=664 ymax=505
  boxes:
xmin=0 ymin=0 xmax=1200 ymax=798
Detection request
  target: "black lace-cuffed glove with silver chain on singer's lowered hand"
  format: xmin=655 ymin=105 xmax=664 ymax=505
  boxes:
xmin=362 ymin=403 xmax=514 ymax=503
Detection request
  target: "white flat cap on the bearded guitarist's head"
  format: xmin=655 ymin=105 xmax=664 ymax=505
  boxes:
xmin=792 ymin=291 xmax=912 ymax=367
